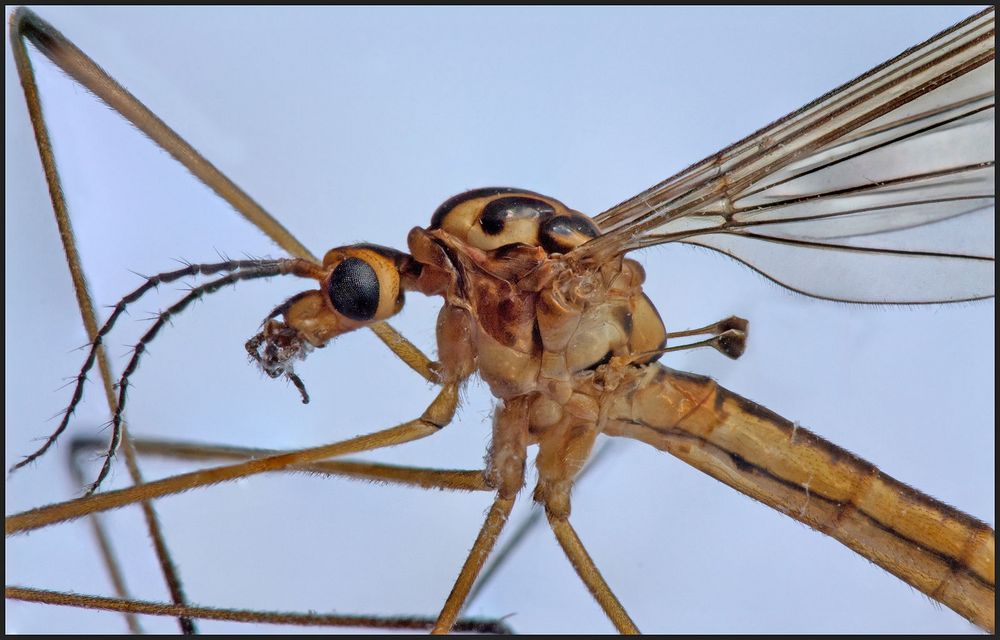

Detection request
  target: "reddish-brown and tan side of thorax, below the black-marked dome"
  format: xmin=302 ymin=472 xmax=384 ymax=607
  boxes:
xmin=438 ymin=248 xmax=666 ymax=402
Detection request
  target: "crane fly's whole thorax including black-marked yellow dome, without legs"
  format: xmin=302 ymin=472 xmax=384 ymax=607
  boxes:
xmin=418 ymin=188 xmax=666 ymax=404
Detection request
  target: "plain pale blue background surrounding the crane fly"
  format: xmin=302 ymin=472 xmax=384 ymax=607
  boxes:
xmin=5 ymin=7 xmax=995 ymax=633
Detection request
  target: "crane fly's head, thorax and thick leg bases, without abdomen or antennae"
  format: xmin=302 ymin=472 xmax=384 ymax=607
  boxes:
xmin=247 ymin=188 xmax=680 ymax=519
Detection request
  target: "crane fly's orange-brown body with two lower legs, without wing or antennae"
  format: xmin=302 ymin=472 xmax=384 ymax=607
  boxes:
xmin=242 ymin=188 xmax=993 ymax=633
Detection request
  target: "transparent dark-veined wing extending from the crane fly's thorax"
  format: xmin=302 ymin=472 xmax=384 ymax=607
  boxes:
xmin=573 ymin=8 xmax=995 ymax=303
